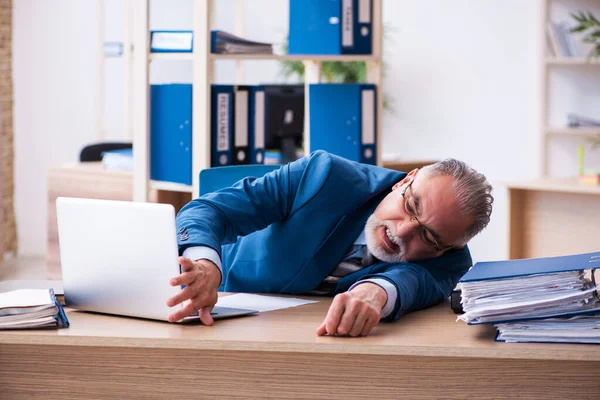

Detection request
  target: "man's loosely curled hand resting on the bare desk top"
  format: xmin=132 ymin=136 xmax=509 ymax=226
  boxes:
xmin=317 ymin=282 xmax=387 ymax=336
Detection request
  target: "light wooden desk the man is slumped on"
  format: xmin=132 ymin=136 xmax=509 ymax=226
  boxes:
xmin=0 ymin=299 xmax=600 ymax=400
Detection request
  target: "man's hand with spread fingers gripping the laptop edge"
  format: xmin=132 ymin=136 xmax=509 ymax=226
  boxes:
xmin=167 ymin=257 xmax=221 ymax=325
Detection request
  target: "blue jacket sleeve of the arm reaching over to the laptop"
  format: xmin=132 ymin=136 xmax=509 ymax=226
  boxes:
xmin=177 ymin=151 xmax=331 ymax=256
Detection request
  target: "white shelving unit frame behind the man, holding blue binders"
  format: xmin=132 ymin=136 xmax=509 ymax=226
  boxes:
xmin=130 ymin=0 xmax=383 ymax=202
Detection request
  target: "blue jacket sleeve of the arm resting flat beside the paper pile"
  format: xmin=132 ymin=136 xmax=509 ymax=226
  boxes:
xmin=354 ymin=246 xmax=472 ymax=321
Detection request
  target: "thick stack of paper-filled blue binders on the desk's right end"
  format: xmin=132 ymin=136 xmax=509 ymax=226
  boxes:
xmin=458 ymin=252 xmax=600 ymax=344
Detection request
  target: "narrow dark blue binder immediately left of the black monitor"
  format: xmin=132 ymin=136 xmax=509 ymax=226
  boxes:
xmin=248 ymin=86 xmax=265 ymax=164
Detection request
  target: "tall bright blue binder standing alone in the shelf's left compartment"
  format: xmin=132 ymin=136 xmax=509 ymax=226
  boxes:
xmin=150 ymin=84 xmax=192 ymax=185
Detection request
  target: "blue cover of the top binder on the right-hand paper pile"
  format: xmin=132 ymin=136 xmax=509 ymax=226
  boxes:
xmin=460 ymin=252 xmax=600 ymax=282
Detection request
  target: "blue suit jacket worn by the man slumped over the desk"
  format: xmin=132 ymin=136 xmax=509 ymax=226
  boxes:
xmin=177 ymin=151 xmax=472 ymax=319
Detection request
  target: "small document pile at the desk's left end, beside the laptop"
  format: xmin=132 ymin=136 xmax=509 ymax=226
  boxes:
xmin=0 ymin=289 xmax=69 ymax=329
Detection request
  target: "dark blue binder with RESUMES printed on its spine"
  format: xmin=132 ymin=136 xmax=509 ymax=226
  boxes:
xmin=210 ymin=85 xmax=235 ymax=167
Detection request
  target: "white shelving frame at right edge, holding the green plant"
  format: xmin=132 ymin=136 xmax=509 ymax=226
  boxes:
xmin=540 ymin=0 xmax=600 ymax=180
